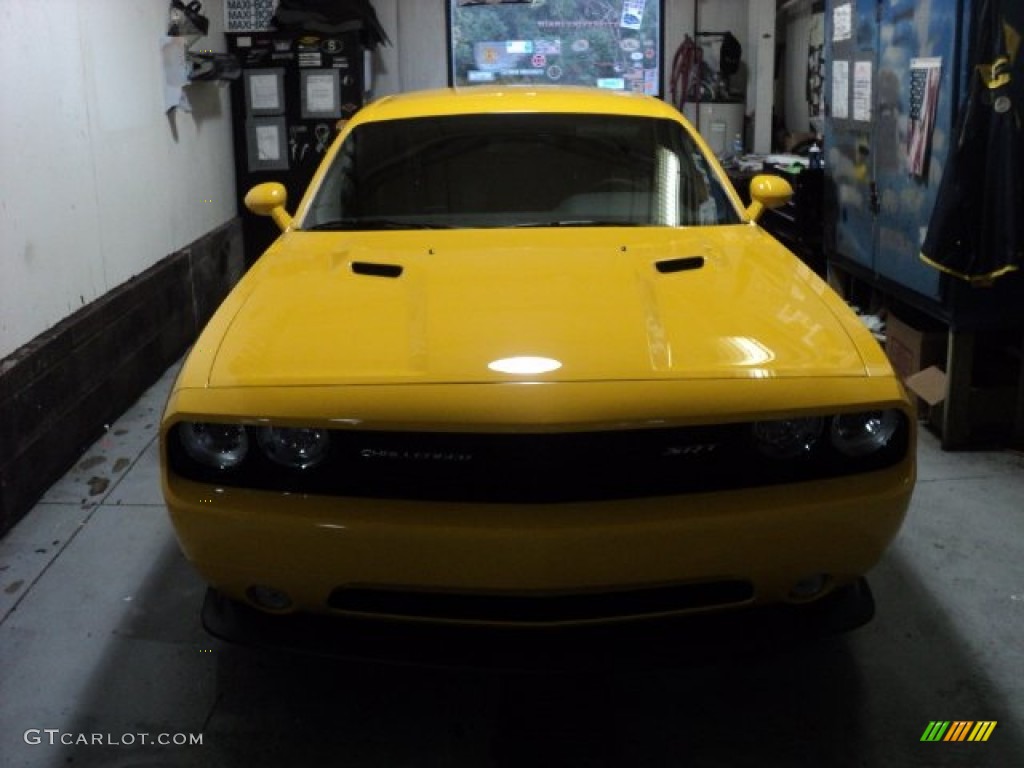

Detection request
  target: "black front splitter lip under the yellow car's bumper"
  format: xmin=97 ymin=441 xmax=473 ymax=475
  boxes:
xmin=202 ymin=579 xmax=874 ymax=672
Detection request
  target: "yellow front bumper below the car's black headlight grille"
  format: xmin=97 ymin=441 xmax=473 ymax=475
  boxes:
xmin=165 ymin=461 xmax=913 ymax=627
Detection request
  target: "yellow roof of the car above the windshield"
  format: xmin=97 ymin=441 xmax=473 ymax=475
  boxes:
xmin=352 ymin=85 xmax=679 ymax=123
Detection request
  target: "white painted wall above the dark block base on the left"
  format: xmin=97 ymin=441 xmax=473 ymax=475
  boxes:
xmin=0 ymin=0 xmax=236 ymax=357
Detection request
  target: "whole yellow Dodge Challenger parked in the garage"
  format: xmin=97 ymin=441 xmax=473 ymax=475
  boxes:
xmin=161 ymin=87 xmax=915 ymax=643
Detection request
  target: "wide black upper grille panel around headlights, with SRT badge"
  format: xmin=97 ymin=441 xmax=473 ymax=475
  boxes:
xmin=167 ymin=419 xmax=908 ymax=503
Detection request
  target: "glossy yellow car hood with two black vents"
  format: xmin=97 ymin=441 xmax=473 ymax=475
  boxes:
xmin=205 ymin=225 xmax=869 ymax=387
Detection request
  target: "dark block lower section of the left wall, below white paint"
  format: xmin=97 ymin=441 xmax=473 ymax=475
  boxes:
xmin=0 ymin=219 xmax=244 ymax=536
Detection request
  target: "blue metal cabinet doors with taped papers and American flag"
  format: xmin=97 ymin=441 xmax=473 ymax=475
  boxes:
xmin=825 ymin=0 xmax=969 ymax=301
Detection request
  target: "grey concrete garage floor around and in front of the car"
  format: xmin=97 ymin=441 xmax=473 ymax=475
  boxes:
xmin=0 ymin=362 xmax=1024 ymax=768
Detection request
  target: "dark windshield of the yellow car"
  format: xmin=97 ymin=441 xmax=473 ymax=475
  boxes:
xmin=302 ymin=113 xmax=738 ymax=229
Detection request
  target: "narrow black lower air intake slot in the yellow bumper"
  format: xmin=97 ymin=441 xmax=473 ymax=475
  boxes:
xmin=328 ymin=581 xmax=754 ymax=624
